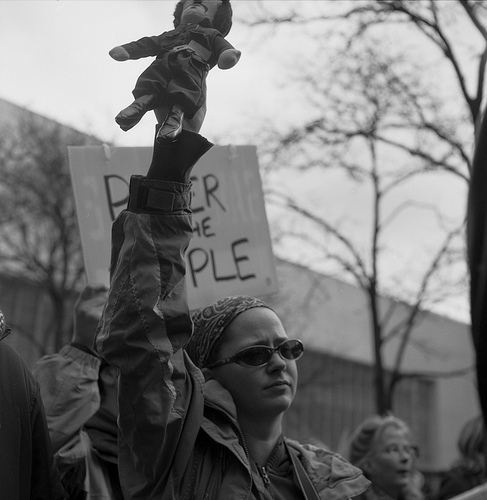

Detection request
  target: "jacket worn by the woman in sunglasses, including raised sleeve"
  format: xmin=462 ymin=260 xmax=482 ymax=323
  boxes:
xmin=97 ymin=176 xmax=369 ymax=500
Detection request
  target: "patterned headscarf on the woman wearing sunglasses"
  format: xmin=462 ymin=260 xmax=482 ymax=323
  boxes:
xmin=186 ymin=295 xmax=271 ymax=368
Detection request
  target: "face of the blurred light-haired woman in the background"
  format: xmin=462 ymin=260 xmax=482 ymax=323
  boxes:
xmin=363 ymin=426 xmax=417 ymax=498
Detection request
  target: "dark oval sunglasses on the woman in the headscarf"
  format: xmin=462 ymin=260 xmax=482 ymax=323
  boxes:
xmin=207 ymin=340 xmax=304 ymax=368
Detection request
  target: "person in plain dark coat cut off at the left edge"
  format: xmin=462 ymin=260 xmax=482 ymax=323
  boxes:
xmin=0 ymin=311 xmax=65 ymax=500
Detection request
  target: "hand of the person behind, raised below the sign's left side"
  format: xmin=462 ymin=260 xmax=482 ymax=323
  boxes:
xmin=71 ymin=285 xmax=108 ymax=348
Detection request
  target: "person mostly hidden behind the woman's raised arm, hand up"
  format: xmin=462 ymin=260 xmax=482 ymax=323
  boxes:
xmin=33 ymin=286 xmax=123 ymax=500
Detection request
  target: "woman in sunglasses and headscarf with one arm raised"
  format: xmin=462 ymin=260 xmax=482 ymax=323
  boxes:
xmin=96 ymin=130 xmax=369 ymax=500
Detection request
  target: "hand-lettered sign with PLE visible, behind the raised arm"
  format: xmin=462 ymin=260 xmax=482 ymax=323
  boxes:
xmin=68 ymin=146 xmax=277 ymax=309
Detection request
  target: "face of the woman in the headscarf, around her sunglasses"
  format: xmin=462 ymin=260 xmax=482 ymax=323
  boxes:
xmin=211 ymin=307 xmax=298 ymax=422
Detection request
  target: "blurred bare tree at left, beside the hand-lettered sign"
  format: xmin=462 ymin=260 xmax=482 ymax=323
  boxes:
xmin=0 ymin=111 xmax=99 ymax=348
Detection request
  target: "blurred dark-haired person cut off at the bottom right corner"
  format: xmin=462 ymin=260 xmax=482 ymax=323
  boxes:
xmin=438 ymin=415 xmax=487 ymax=500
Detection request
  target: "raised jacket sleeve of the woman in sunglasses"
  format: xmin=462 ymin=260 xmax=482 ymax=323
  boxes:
xmin=96 ymin=181 xmax=203 ymax=499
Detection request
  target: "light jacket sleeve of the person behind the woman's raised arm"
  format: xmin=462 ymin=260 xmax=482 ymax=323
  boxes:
xmin=33 ymin=345 xmax=101 ymax=452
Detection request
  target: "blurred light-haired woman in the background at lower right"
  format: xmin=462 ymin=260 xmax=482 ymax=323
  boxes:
xmin=348 ymin=415 xmax=424 ymax=500
